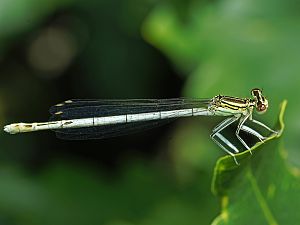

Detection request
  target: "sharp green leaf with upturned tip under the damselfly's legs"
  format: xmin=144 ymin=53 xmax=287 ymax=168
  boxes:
xmin=212 ymin=101 xmax=300 ymax=225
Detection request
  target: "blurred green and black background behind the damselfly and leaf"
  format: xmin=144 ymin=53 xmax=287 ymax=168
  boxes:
xmin=0 ymin=0 xmax=300 ymax=225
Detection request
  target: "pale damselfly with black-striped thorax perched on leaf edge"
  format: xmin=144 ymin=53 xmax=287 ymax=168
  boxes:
xmin=4 ymin=88 xmax=277 ymax=164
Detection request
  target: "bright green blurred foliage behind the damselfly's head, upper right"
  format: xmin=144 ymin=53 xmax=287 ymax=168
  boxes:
xmin=143 ymin=0 xmax=300 ymax=164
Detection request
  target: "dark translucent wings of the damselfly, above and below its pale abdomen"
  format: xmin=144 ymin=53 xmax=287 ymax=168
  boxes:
xmin=49 ymin=98 xmax=210 ymax=140
